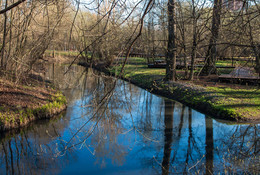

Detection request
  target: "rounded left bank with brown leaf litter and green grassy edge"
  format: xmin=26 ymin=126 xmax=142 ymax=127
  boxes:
xmin=0 ymin=73 xmax=66 ymax=132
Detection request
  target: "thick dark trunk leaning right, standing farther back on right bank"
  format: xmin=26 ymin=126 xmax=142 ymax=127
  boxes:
xmin=202 ymin=0 xmax=222 ymax=75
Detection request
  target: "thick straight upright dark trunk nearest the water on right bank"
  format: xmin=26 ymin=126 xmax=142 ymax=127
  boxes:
xmin=165 ymin=0 xmax=177 ymax=81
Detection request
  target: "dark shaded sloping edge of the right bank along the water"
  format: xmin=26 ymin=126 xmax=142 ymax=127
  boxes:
xmin=82 ymin=63 xmax=260 ymax=123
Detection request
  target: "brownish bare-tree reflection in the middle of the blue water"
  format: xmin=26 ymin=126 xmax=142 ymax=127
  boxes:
xmin=65 ymin=75 xmax=133 ymax=167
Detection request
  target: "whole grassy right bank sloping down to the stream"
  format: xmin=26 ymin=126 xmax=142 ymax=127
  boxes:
xmin=106 ymin=58 xmax=260 ymax=121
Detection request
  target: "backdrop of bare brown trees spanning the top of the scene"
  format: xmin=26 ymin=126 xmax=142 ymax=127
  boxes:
xmin=0 ymin=0 xmax=260 ymax=80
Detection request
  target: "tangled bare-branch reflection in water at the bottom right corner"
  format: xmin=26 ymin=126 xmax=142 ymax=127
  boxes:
xmin=217 ymin=125 xmax=260 ymax=174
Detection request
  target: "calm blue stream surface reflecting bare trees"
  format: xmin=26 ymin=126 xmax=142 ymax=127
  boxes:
xmin=0 ymin=65 xmax=260 ymax=175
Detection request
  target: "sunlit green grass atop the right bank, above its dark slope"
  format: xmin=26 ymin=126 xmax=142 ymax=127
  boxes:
xmin=106 ymin=58 xmax=260 ymax=119
